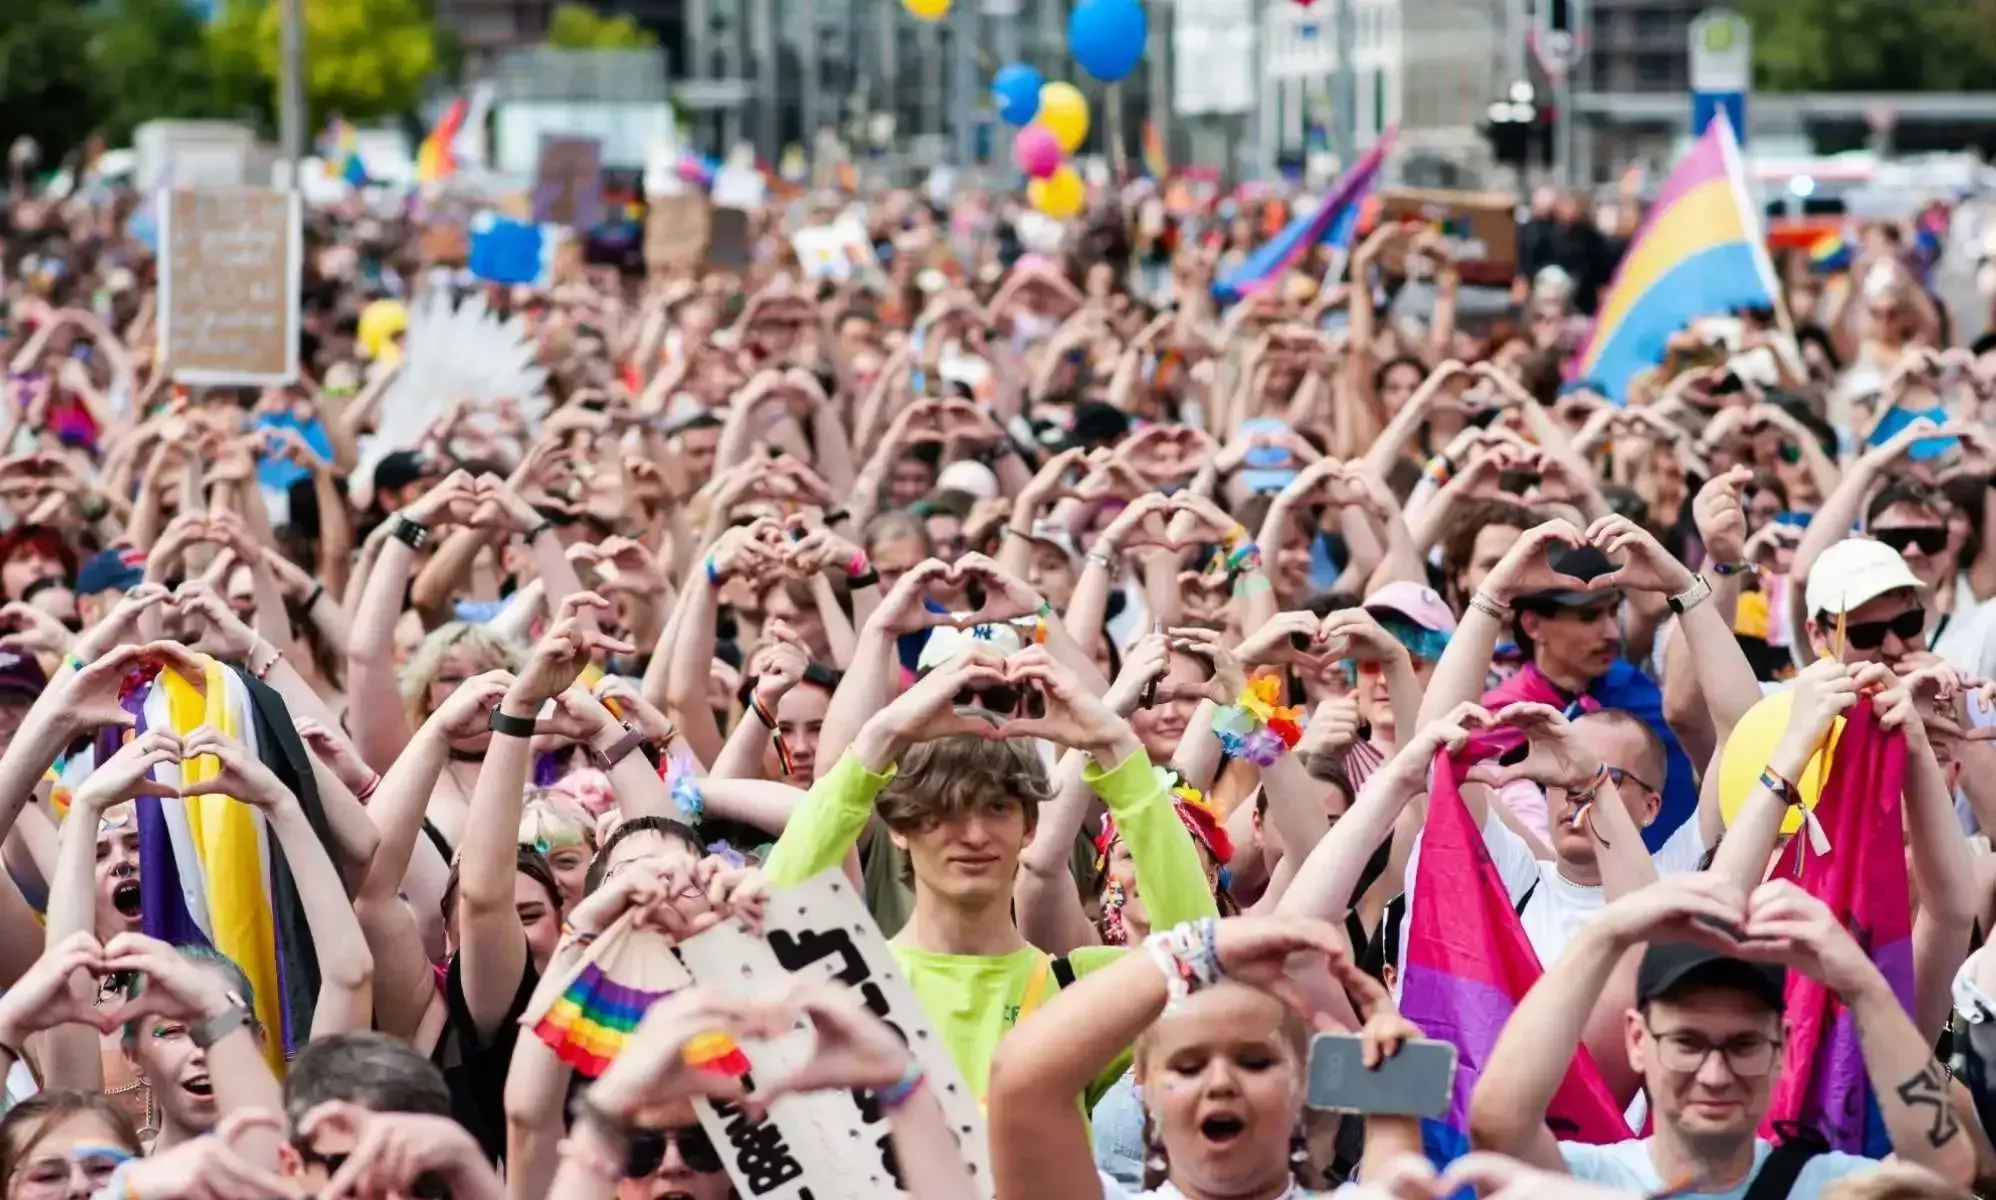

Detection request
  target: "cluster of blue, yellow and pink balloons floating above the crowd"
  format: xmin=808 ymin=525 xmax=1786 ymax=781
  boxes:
xmin=982 ymin=0 xmax=1150 ymax=220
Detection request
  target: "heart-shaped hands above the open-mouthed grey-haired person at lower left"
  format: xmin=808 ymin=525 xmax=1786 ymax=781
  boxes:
xmin=0 ymin=930 xmax=253 ymax=1058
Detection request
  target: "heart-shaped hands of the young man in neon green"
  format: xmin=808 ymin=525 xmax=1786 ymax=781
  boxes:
xmin=852 ymin=645 xmax=1142 ymax=771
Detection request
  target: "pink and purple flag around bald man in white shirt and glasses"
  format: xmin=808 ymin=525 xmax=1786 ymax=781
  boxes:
xmin=1399 ymin=753 xmax=1629 ymax=1166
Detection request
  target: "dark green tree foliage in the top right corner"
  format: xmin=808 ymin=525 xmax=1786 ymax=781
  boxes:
xmin=1739 ymin=0 xmax=1996 ymax=92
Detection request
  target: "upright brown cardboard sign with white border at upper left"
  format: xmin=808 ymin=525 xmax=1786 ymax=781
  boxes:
xmin=156 ymin=188 xmax=305 ymax=385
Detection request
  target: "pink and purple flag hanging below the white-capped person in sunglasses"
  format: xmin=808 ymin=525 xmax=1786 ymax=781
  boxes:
xmin=1762 ymin=705 xmax=1912 ymax=1158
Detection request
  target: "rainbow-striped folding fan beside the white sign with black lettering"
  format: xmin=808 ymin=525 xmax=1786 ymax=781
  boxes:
xmin=521 ymin=910 xmax=689 ymax=1078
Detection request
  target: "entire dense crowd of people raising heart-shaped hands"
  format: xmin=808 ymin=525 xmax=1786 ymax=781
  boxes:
xmin=0 ymin=165 xmax=1996 ymax=1200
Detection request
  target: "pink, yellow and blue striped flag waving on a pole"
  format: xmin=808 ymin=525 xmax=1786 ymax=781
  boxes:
xmin=1567 ymin=114 xmax=1778 ymax=401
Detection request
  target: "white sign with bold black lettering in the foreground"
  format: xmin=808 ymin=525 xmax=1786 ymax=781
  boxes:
xmin=679 ymin=869 xmax=994 ymax=1200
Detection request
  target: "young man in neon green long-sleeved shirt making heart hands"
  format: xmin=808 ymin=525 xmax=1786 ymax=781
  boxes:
xmin=764 ymin=647 xmax=1218 ymax=1104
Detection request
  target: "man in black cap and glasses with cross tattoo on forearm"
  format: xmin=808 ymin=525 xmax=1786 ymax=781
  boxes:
xmin=1469 ymin=871 xmax=1974 ymax=1200
